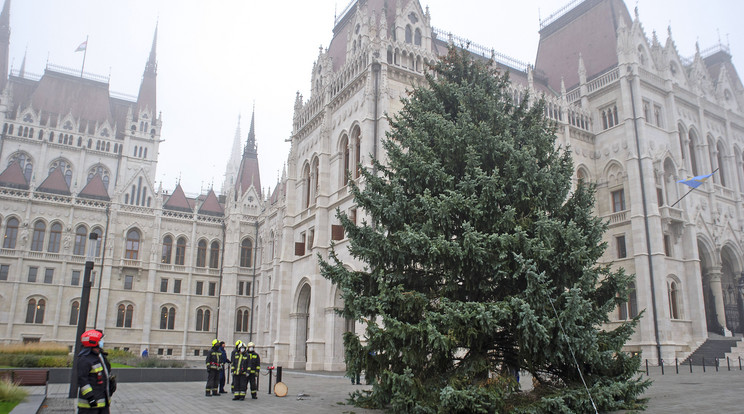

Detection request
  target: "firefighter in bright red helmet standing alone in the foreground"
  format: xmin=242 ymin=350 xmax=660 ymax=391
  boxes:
xmin=77 ymin=330 xmax=116 ymax=414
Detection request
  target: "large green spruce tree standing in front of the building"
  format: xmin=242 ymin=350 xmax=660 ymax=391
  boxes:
xmin=321 ymin=48 xmax=648 ymax=413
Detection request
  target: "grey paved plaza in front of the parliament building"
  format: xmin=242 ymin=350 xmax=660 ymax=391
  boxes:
xmin=26 ymin=367 xmax=744 ymax=414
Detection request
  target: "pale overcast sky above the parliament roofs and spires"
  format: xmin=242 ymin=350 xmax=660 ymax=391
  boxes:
xmin=7 ymin=0 xmax=744 ymax=195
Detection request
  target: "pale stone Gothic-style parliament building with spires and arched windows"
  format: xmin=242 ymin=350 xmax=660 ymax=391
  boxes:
xmin=0 ymin=0 xmax=744 ymax=370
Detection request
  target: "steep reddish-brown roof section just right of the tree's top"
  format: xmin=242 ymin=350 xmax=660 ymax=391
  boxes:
xmin=535 ymin=0 xmax=633 ymax=91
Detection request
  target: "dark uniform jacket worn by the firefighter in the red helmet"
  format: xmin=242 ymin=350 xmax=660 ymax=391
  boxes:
xmin=77 ymin=348 xmax=115 ymax=408
